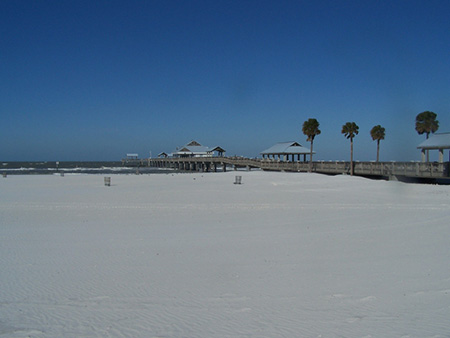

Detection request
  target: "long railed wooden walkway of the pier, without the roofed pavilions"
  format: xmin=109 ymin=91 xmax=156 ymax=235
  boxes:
xmin=122 ymin=157 xmax=450 ymax=179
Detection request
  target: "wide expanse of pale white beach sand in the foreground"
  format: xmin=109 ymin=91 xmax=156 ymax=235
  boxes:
xmin=0 ymin=172 xmax=450 ymax=337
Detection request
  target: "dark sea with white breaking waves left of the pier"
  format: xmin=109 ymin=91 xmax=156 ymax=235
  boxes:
xmin=0 ymin=161 xmax=175 ymax=175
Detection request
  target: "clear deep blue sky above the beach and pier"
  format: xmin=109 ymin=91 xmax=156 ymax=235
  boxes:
xmin=0 ymin=0 xmax=450 ymax=161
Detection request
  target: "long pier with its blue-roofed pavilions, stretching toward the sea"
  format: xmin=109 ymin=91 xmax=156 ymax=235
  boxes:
xmin=122 ymin=133 xmax=450 ymax=183
